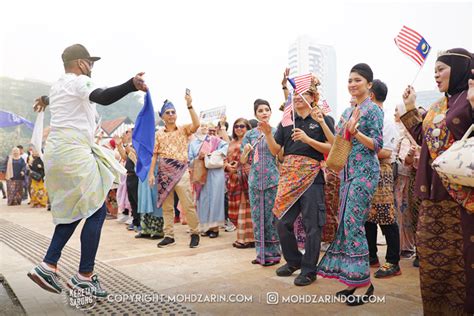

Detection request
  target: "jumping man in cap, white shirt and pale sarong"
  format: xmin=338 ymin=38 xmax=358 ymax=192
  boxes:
xmin=28 ymin=44 xmax=148 ymax=298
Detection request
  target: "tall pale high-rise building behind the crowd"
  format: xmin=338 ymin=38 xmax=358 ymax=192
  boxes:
xmin=288 ymin=36 xmax=343 ymax=118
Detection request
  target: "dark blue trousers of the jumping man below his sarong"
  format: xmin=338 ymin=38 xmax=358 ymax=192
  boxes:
xmin=43 ymin=203 xmax=107 ymax=273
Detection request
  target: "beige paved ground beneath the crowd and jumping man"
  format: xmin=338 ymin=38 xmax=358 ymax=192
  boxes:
xmin=0 ymin=196 xmax=422 ymax=315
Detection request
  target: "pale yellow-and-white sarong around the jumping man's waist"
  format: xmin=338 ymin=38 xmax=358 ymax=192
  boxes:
xmin=44 ymin=128 xmax=126 ymax=224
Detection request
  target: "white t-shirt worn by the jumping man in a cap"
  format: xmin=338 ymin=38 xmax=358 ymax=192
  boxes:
xmin=49 ymin=73 xmax=99 ymax=141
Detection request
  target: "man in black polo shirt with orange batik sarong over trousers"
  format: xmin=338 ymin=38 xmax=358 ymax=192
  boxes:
xmin=259 ymin=79 xmax=334 ymax=286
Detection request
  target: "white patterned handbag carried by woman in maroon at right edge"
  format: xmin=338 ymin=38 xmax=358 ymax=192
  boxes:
xmin=431 ymin=124 xmax=474 ymax=187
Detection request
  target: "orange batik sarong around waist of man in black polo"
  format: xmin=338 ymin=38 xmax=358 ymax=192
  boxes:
xmin=273 ymin=155 xmax=321 ymax=219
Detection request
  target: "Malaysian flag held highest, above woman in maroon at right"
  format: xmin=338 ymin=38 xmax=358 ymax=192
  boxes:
xmin=395 ymin=25 xmax=431 ymax=66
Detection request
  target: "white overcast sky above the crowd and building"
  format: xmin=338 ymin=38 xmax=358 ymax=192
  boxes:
xmin=0 ymin=0 xmax=474 ymax=125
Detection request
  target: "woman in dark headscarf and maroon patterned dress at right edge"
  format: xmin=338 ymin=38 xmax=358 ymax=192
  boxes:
xmin=400 ymin=48 xmax=474 ymax=315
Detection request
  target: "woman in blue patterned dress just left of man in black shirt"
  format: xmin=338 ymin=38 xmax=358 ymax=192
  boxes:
xmin=240 ymin=99 xmax=281 ymax=266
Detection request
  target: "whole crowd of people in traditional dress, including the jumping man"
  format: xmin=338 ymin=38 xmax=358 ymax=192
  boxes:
xmin=7 ymin=45 xmax=474 ymax=315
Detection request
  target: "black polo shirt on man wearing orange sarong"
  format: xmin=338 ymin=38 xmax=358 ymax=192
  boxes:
xmin=274 ymin=114 xmax=334 ymax=183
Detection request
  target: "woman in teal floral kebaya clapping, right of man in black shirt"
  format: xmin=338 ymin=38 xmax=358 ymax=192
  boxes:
xmin=318 ymin=64 xmax=383 ymax=306
